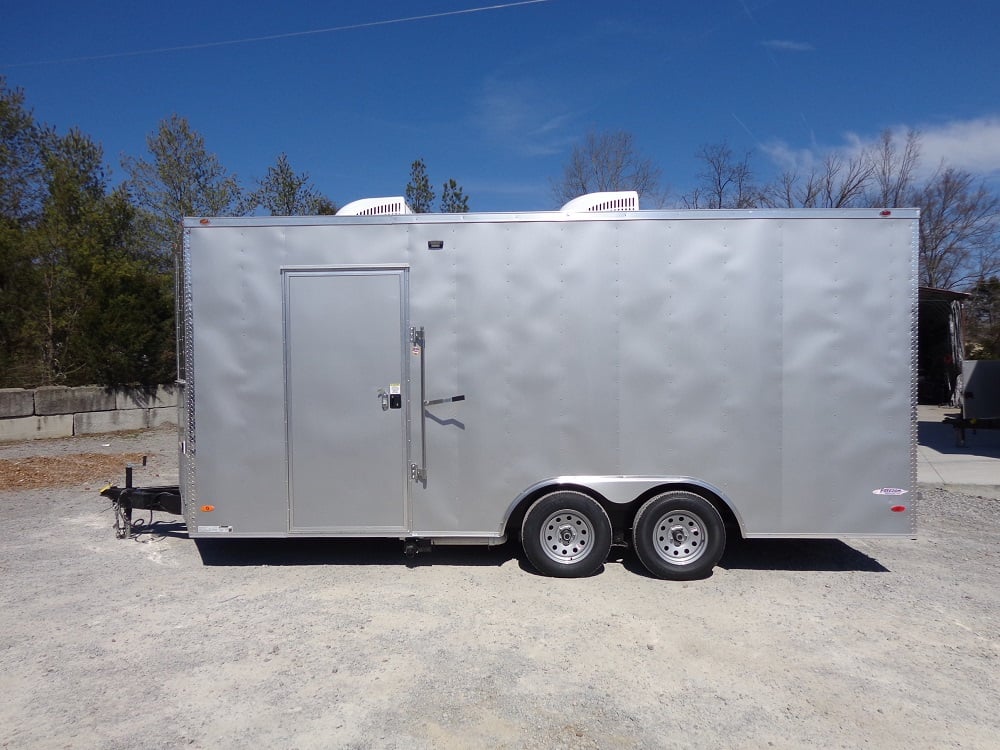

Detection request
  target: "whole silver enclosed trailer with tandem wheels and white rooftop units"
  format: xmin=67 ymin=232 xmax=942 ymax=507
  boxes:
xmin=168 ymin=196 xmax=918 ymax=578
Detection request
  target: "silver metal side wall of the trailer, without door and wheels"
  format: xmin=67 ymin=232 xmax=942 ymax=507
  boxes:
xmin=185 ymin=211 xmax=916 ymax=537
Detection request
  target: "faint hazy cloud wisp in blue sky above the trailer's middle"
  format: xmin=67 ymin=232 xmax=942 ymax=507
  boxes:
xmin=472 ymin=80 xmax=574 ymax=156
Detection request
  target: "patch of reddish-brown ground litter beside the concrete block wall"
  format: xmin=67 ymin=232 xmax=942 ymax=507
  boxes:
xmin=0 ymin=453 xmax=143 ymax=491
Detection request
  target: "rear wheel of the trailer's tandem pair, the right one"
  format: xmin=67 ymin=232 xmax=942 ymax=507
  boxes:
xmin=632 ymin=491 xmax=726 ymax=581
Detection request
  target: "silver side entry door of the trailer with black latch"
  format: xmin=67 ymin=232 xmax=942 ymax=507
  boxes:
xmin=282 ymin=267 xmax=409 ymax=535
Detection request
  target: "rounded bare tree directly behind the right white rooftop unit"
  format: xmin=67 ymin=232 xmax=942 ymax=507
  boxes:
xmin=552 ymin=130 xmax=663 ymax=204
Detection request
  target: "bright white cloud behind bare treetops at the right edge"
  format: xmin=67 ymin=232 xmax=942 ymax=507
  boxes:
xmin=763 ymin=115 xmax=1000 ymax=182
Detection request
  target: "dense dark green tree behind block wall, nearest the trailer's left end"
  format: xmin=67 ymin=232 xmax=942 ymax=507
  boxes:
xmin=26 ymin=130 xmax=173 ymax=385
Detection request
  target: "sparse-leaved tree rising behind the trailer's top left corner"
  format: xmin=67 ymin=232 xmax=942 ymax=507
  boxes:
xmin=122 ymin=114 xmax=246 ymax=258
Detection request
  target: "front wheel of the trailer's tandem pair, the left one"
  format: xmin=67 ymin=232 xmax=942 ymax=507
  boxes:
xmin=521 ymin=491 xmax=611 ymax=578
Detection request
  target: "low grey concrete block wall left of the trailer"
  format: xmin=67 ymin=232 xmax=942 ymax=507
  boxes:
xmin=0 ymin=385 xmax=178 ymax=441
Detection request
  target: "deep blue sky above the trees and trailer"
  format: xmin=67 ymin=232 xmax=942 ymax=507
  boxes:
xmin=0 ymin=0 xmax=1000 ymax=211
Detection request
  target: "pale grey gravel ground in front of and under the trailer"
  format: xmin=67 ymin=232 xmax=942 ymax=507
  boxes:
xmin=0 ymin=429 xmax=1000 ymax=750
